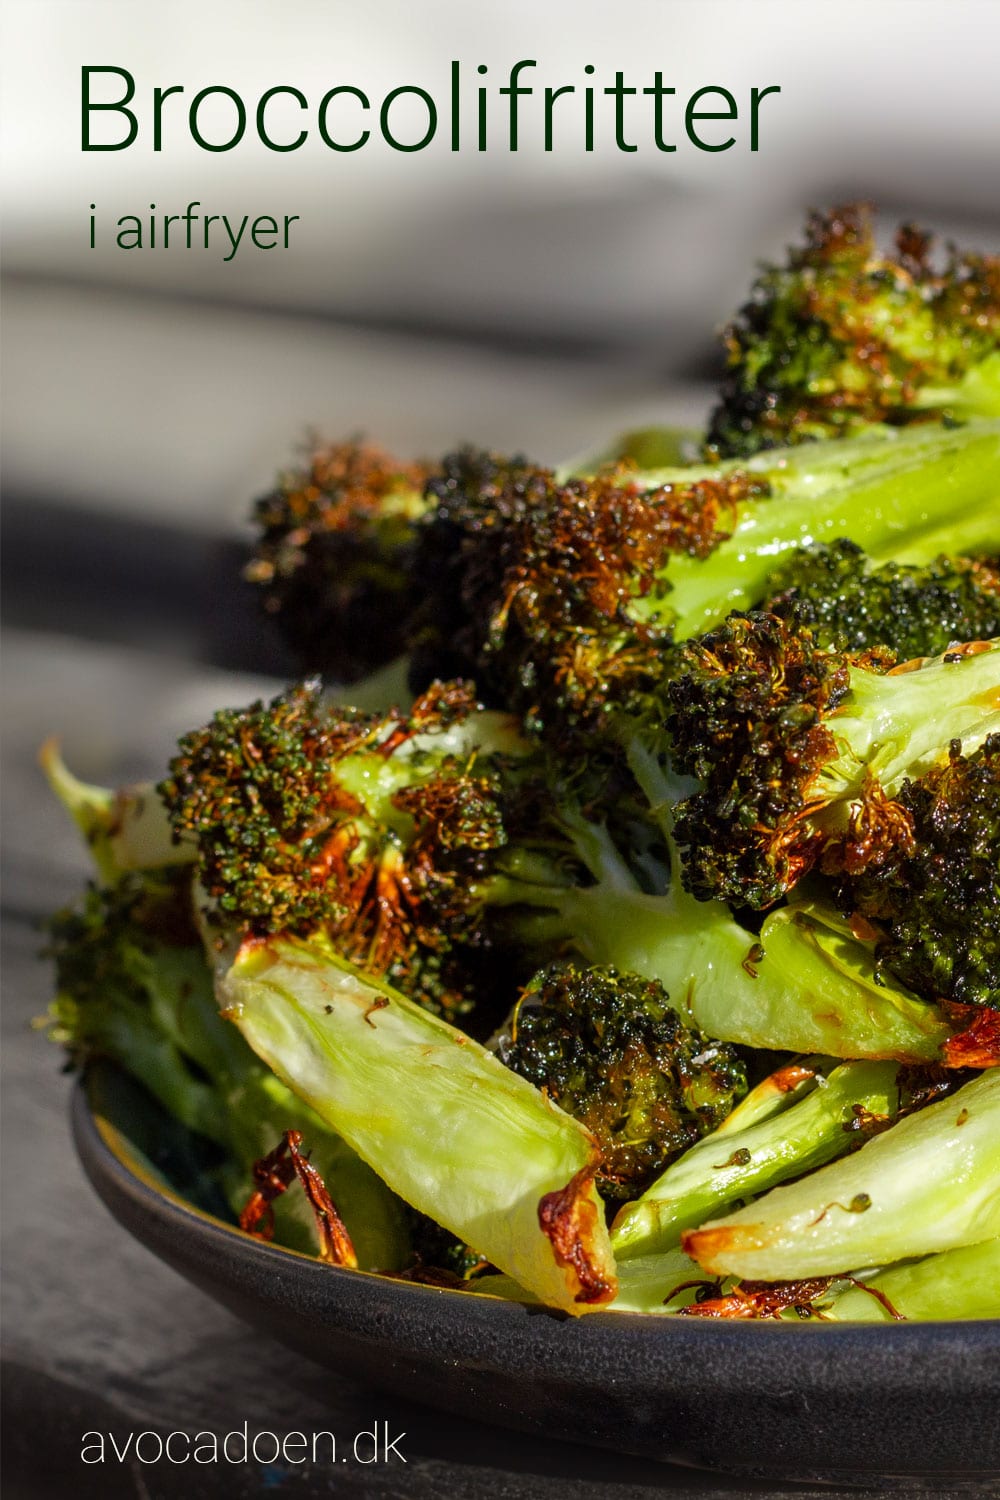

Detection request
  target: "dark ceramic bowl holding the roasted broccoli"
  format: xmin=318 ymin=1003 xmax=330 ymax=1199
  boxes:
xmin=73 ymin=1068 xmax=1000 ymax=1493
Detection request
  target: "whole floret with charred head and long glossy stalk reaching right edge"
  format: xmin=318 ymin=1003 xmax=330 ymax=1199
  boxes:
xmin=407 ymin=423 xmax=1000 ymax=738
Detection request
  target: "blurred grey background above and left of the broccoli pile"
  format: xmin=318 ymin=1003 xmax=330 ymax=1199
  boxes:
xmin=0 ymin=0 xmax=1000 ymax=1497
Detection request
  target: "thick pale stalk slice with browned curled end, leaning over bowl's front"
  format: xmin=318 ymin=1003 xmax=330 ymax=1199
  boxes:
xmin=219 ymin=939 xmax=616 ymax=1313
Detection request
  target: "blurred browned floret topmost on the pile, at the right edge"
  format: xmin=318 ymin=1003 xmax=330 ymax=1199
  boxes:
xmin=708 ymin=204 xmax=1000 ymax=456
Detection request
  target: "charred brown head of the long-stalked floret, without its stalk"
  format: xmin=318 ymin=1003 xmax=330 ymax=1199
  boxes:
xmin=417 ymin=450 xmax=758 ymax=731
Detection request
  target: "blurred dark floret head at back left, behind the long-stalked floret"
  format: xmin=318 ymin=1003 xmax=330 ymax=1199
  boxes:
xmin=246 ymin=443 xmax=429 ymax=681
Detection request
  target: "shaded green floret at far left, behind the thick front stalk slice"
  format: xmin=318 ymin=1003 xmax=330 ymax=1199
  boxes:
xmin=49 ymin=869 xmax=409 ymax=1271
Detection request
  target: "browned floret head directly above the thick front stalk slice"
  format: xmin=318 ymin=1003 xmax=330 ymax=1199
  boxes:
xmin=159 ymin=681 xmax=528 ymax=1013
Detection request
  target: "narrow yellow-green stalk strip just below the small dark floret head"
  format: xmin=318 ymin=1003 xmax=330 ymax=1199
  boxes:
xmin=612 ymin=1062 xmax=900 ymax=1259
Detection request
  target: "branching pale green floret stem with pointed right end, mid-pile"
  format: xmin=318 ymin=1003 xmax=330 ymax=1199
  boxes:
xmin=461 ymin=743 xmax=949 ymax=1062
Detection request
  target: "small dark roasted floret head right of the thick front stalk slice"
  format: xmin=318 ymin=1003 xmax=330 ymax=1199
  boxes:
xmin=499 ymin=963 xmax=747 ymax=1202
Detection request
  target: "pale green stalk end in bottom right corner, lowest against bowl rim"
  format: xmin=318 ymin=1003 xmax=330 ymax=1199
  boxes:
xmin=823 ymin=1239 xmax=1000 ymax=1323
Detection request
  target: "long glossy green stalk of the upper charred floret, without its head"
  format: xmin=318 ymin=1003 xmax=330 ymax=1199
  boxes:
xmin=642 ymin=420 xmax=1000 ymax=641
